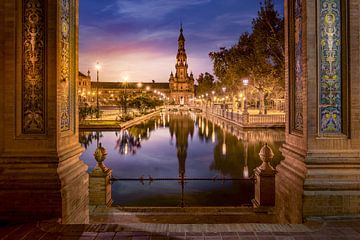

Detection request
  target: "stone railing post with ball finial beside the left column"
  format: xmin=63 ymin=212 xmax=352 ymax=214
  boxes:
xmin=89 ymin=143 xmax=112 ymax=206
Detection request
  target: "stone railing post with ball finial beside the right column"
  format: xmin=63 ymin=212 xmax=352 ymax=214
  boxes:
xmin=253 ymin=144 xmax=276 ymax=207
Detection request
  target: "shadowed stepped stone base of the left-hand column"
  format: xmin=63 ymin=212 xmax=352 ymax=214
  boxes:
xmin=0 ymin=148 xmax=89 ymax=224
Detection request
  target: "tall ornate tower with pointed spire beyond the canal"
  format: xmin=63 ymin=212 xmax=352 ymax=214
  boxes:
xmin=169 ymin=26 xmax=194 ymax=105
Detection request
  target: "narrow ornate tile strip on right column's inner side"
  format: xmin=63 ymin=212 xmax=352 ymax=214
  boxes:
xmin=294 ymin=0 xmax=303 ymax=131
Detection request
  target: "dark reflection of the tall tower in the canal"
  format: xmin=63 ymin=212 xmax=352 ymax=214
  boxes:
xmin=169 ymin=112 xmax=194 ymax=176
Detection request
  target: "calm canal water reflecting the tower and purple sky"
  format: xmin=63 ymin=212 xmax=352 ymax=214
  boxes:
xmin=80 ymin=112 xmax=284 ymax=206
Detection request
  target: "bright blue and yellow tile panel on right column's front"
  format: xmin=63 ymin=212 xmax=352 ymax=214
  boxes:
xmin=319 ymin=0 xmax=342 ymax=134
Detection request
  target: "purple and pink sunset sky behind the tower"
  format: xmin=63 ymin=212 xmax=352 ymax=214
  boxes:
xmin=79 ymin=0 xmax=283 ymax=82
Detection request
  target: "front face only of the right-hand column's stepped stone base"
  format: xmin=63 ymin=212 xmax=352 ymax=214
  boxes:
xmin=303 ymin=153 xmax=360 ymax=218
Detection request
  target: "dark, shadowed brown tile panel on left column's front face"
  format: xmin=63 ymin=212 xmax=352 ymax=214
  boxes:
xmin=22 ymin=0 xmax=46 ymax=134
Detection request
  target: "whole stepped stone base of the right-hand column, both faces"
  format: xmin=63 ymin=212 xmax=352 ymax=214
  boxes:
xmin=275 ymin=144 xmax=360 ymax=223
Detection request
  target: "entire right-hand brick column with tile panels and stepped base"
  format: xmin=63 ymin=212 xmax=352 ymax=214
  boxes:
xmin=276 ymin=0 xmax=360 ymax=223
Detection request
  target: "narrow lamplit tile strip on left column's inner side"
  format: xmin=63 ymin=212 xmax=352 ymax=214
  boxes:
xmin=60 ymin=0 xmax=73 ymax=131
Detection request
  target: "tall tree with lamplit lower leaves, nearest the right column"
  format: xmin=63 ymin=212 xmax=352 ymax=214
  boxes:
xmin=251 ymin=0 xmax=285 ymax=113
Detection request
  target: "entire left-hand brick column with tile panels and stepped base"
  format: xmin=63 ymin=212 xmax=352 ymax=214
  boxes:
xmin=0 ymin=0 xmax=88 ymax=223
